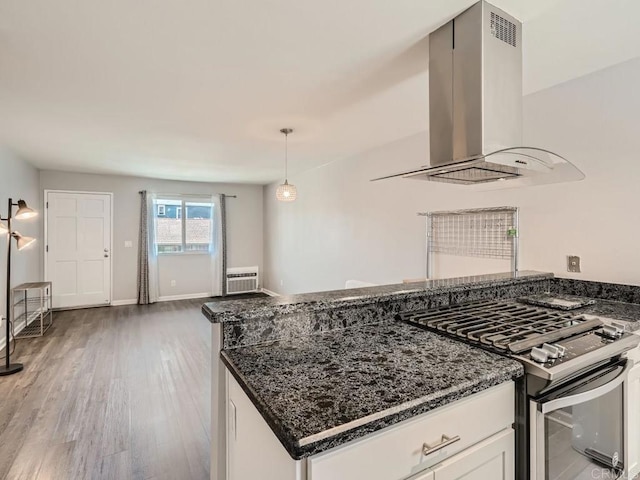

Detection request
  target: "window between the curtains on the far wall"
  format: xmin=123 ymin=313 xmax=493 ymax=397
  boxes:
xmin=155 ymin=199 xmax=213 ymax=254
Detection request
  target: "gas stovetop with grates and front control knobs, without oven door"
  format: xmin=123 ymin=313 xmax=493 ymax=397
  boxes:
xmin=398 ymin=301 xmax=640 ymax=380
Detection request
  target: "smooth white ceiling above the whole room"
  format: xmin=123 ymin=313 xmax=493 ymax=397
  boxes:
xmin=0 ymin=0 xmax=640 ymax=183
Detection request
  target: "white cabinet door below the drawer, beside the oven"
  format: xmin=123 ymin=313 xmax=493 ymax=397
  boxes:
xmin=433 ymin=428 xmax=515 ymax=480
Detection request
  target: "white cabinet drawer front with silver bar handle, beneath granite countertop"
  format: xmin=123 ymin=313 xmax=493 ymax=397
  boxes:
xmin=307 ymin=382 xmax=514 ymax=480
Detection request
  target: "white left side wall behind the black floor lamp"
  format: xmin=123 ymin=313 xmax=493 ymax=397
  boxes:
xmin=0 ymin=147 xmax=42 ymax=334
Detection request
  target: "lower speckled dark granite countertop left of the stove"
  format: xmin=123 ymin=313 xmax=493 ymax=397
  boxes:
xmin=221 ymin=321 xmax=524 ymax=459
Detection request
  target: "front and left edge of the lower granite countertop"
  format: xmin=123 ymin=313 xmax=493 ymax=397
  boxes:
xmin=220 ymin=345 xmax=524 ymax=460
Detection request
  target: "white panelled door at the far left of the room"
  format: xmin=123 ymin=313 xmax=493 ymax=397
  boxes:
xmin=45 ymin=192 xmax=111 ymax=308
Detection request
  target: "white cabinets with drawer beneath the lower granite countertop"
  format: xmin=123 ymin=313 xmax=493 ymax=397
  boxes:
xmin=226 ymin=373 xmax=514 ymax=480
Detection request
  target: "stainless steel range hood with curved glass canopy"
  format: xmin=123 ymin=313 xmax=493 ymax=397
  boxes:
xmin=374 ymin=0 xmax=584 ymax=188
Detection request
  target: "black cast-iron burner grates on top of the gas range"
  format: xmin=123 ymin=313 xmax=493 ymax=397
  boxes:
xmin=398 ymin=301 xmax=600 ymax=353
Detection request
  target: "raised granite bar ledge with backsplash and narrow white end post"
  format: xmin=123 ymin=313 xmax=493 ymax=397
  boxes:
xmin=202 ymin=271 xmax=553 ymax=480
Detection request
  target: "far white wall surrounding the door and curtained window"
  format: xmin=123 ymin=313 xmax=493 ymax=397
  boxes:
xmin=40 ymin=170 xmax=263 ymax=302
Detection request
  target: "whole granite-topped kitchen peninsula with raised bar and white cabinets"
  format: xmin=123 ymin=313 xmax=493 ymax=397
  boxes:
xmin=203 ymin=272 xmax=640 ymax=480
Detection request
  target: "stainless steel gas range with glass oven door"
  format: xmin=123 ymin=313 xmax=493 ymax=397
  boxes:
xmin=398 ymin=301 xmax=640 ymax=480
